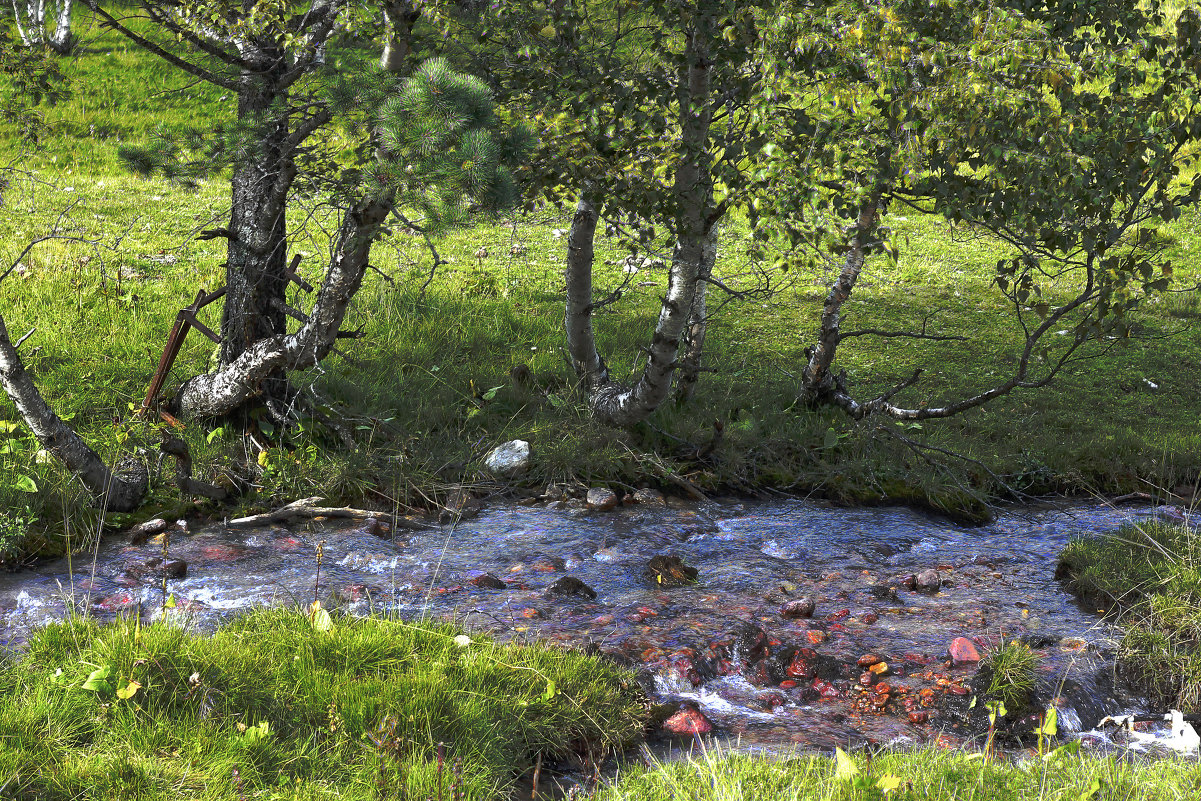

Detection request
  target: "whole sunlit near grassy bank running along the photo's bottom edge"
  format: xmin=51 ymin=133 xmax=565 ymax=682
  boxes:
xmin=7 ymin=610 xmax=1201 ymax=801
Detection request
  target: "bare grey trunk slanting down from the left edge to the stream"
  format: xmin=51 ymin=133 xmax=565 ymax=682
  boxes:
xmin=0 ymin=316 xmax=150 ymax=512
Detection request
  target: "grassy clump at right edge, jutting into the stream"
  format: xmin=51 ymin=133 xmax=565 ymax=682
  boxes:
xmin=1057 ymin=522 xmax=1201 ymax=712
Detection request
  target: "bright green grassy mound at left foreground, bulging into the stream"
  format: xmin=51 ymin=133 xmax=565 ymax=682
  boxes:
xmin=0 ymin=610 xmax=645 ymax=801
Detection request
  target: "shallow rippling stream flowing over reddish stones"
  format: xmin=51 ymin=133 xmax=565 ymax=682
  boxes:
xmin=0 ymin=501 xmax=1176 ymax=748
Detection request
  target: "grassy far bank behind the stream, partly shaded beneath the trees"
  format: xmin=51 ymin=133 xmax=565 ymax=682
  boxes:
xmin=0 ymin=14 xmax=1201 ymax=564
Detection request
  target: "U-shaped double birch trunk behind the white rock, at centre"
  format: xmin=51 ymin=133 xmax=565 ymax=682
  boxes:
xmin=566 ymin=9 xmax=716 ymax=428
